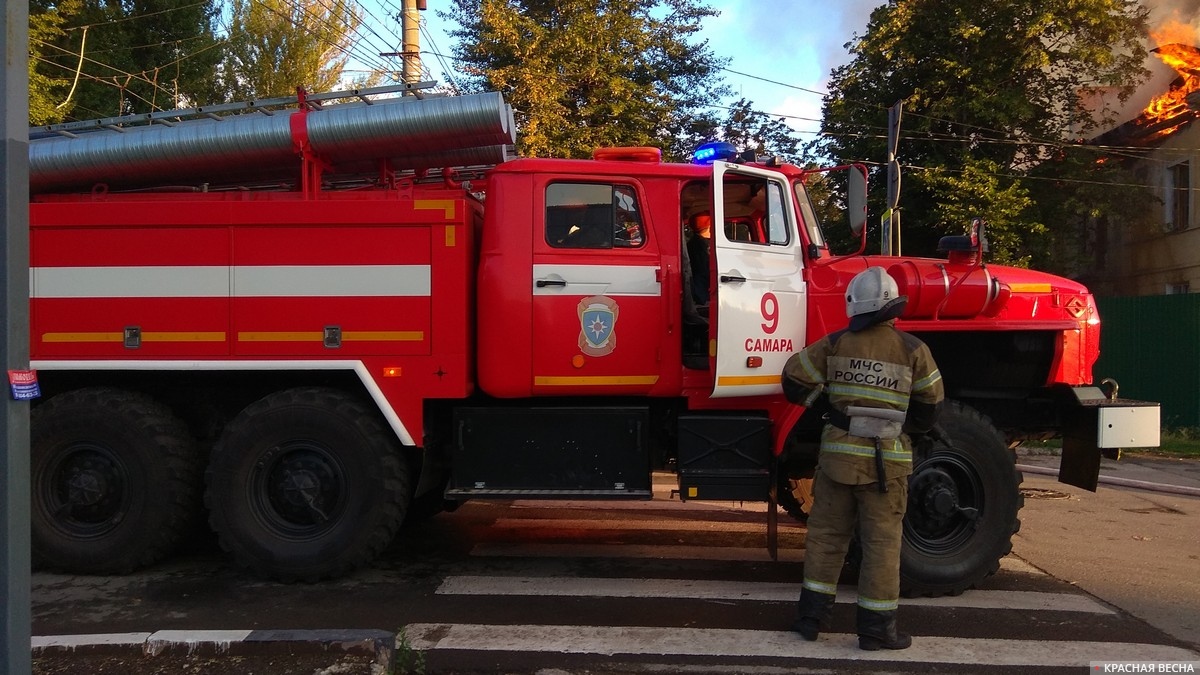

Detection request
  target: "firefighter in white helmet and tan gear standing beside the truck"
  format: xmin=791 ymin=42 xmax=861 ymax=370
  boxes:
xmin=784 ymin=267 xmax=943 ymax=651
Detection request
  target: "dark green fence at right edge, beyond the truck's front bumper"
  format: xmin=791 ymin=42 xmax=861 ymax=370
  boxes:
xmin=1092 ymin=293 xmax=1200 ymax=429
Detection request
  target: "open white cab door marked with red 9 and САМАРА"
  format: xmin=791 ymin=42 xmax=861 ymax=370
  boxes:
xmin=709 ymin=162 xmax=806 ymax=398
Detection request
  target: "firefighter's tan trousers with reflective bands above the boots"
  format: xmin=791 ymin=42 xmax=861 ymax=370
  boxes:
xmin=804 ymin=466 xmax=908 ymax=611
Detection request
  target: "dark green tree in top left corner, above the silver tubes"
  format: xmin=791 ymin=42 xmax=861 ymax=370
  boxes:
xmin=30 ymin=0 xmax=221 ymax=119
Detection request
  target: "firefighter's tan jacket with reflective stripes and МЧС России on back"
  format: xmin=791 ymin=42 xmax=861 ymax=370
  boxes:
xmin=784 ymin=319 xmax=944 ymax=485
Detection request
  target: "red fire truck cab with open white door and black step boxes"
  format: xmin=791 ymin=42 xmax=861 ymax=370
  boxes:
xmin=448 ymin=148 xmax=820 ymax=500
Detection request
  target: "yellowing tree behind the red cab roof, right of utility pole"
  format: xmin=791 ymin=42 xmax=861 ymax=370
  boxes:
xmin=442 ymin=0 xmax=730 ymax=159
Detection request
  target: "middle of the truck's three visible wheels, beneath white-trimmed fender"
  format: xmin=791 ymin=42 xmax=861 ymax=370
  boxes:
xmin=204 ymin=388 xmax=409 ymax=581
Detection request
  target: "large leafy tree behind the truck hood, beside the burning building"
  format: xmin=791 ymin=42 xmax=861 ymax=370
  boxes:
xmin=815 ymin=0 xmax=1148 ymax=263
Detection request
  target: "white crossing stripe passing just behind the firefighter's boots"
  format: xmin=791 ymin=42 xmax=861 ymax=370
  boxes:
xmin=437 ymin=575 xmax=1115 ymax=614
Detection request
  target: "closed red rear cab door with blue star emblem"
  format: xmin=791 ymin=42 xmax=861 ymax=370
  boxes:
xmin=530 ymin=177 xmax=667 ymax=395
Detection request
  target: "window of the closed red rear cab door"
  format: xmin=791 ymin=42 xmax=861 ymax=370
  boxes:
xmin=546 ymin=183 xmax=644 ymax=249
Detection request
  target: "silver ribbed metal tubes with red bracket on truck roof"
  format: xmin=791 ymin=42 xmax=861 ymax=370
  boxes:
xmin=29 ymin=82 xmax=516 ymax=195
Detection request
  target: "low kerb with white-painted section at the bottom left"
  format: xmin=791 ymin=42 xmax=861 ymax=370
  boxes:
xmin=31 ymin=629 xmax=396 ymax=665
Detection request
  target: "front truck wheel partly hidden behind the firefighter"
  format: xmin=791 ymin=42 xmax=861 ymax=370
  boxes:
xmin=900 ymin=401 xmax=1025 ymax=597
